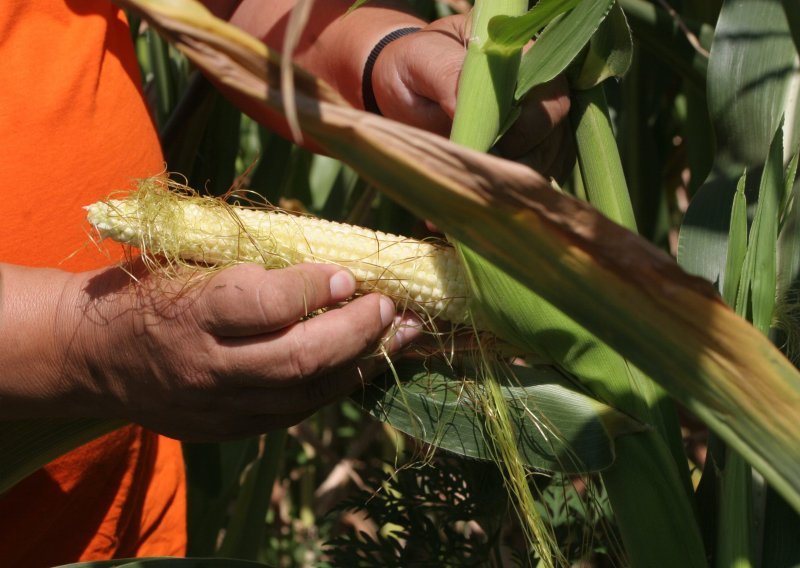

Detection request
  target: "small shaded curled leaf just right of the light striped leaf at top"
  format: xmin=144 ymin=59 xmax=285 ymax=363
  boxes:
xmin=572 ymin=2 xmax=633 ymax=90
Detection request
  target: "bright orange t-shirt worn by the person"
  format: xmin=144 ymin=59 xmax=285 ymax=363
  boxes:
xmin=0 ymin=0 xmax=186 ymax=568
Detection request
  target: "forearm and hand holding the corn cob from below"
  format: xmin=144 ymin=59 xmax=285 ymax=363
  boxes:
xmin=0 ymin=258 xmax=418 ymax=440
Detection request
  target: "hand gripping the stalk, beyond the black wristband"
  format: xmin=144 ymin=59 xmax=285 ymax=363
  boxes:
xmin=372 ymin=15 xmax=575 ymax=180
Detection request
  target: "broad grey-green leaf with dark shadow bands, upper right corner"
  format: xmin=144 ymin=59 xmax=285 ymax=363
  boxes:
xmin=678 ymin=0 xmax=800 ymax=302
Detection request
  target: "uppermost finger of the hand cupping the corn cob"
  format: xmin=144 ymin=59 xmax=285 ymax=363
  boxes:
xmin=194 ymin=264 xmax=356 ymax=337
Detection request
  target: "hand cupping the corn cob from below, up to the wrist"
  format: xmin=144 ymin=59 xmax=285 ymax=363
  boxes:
xmin=66 ymin=265 xmax=419 ymax=440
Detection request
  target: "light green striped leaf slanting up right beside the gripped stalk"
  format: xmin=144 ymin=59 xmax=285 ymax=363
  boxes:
xmin=514 ymin=0 xmax=614 ymax=100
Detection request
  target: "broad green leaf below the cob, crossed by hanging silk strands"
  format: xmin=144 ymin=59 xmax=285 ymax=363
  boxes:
xmin=354 ymin=361 xmax=643 ymax=473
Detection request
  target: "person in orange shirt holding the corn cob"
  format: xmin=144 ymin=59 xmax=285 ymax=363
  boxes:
xmin=0 ymin=0 xmax=569 ymax=568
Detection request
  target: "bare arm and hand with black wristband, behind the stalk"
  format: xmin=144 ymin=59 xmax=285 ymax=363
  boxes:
xmin=221 ymin=0 xmax=575 ymax=179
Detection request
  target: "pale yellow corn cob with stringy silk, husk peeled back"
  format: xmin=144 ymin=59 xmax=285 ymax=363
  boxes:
xmin=86 ymin=180 xmax=476 ymax=324
